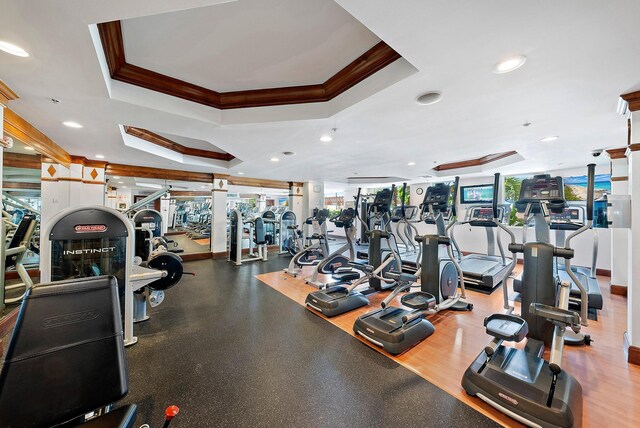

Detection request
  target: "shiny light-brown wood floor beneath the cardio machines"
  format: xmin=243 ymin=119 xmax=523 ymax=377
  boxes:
xmin=257 ymin=270 xmax=640 ymax=427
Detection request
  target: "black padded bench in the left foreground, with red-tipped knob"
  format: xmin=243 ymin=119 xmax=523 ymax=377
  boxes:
xmin=0 ymin=276 xmax=178 ymax=428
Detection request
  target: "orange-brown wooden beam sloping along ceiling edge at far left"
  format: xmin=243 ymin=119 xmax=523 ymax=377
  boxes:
xmin=4 ymin=108 xmax=71 ymax=168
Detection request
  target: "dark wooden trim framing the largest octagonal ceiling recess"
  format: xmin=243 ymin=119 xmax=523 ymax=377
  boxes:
xmin=98 ymin=21 xmax=401 ymax=110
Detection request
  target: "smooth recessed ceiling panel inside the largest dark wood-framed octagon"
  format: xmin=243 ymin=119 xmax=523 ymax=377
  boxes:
xmin=122 ymin=0 xmax=380 ymax=92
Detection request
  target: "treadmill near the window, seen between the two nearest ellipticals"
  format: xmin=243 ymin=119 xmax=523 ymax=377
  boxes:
xmin=450 ymin=205 xmax=511 ymax=293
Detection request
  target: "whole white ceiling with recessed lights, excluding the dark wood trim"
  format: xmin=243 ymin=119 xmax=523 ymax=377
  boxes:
xmin=0 ymin=0 xmax=640 ymax=183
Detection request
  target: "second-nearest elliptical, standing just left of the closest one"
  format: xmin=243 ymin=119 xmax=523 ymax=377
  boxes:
xmin=353 ymin=177 xmax=473 ymax=355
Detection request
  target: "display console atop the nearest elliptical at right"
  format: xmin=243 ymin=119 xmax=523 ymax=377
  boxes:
xmin=515 ymin=174 xmax=565 ymax=213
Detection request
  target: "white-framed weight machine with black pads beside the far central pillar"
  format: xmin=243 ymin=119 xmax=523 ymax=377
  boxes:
xmin=228 ymin=209 xmax=268 ymax=266
